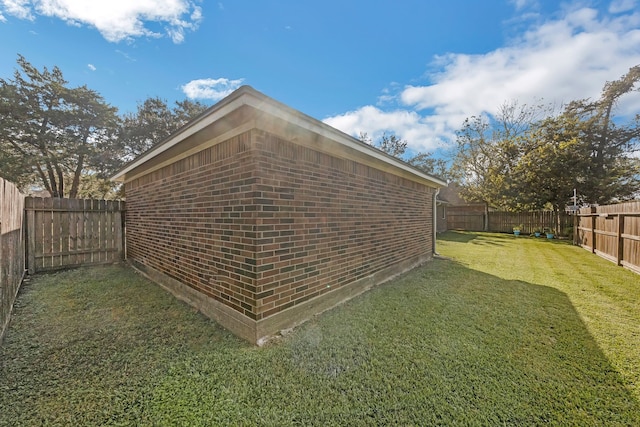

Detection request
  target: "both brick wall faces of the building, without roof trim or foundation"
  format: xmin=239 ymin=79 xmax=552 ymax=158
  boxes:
xmin=126 ymin=130 xmax=434 ymax=326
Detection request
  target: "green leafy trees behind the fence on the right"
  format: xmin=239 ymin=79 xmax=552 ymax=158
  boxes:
xmin=452 ymin=66 xmax=640 ymax=214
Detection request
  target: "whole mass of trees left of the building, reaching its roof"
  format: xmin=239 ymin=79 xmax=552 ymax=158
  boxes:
xmin=0 ymin=56 xmax=207 ymax=198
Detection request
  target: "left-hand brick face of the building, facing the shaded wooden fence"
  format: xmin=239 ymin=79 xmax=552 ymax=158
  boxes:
xmin=125 ymin=132 xmax=256 ymax=319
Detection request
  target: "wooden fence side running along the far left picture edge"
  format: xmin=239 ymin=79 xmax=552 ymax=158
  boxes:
xmin=0 ymin=178 xmax=25 ymax=342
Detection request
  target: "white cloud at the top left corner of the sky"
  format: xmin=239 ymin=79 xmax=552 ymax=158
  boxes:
xmin=0 ymin=0 xmax=202 ymax=43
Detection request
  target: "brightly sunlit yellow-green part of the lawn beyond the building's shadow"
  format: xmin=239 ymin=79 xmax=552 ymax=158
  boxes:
xmin=438 ymin=232 xmax=640 ymax=400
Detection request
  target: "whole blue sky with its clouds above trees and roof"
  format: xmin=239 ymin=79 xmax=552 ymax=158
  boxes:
xmin=0 ymin=0 xmax=640 ymax=151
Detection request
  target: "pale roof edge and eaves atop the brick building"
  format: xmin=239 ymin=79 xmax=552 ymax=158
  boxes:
xmin=111 ymin=86 xmax=447 ymax=188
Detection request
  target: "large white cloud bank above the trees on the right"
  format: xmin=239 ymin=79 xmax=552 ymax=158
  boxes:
xmin=325 ymin=3 xmax=640 ymax=150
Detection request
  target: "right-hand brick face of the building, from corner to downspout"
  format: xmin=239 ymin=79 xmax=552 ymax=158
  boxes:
xmin=254 ymin=132 xmax=434 ymax=319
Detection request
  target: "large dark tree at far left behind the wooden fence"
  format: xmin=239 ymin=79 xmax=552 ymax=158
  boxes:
xmin=0 ymin=55 xmax=117 ymax=197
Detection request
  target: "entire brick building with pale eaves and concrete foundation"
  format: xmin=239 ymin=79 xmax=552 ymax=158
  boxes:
xmin=114 ymin=86 xmax=445 ymax=343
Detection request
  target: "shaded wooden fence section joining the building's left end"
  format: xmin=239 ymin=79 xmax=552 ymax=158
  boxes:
xmin=25 ymin=197 xmax=124 ymax=274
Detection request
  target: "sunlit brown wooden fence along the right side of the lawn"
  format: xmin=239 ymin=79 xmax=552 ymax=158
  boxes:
xmin=575 ymin=202 xmax=640 ymax=273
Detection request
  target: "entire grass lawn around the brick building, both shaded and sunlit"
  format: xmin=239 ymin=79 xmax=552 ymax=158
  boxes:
xmin=0 ymin=233 xmax=640 ymax=426
